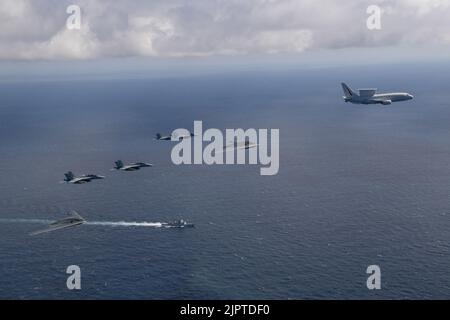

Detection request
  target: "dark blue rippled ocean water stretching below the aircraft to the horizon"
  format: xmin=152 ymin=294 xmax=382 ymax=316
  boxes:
xmin=0 ymin=65 xmax=450 ymax=299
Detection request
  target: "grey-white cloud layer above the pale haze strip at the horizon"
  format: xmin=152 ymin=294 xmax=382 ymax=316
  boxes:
xmin=0 ymin=0 xmax=450 ymax=60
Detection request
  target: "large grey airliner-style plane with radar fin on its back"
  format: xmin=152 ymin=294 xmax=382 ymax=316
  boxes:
xmin=341 ymin=83 xmax=414 ymax=106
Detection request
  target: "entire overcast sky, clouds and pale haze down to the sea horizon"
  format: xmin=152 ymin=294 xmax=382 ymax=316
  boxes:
xmin=0 ymin=0 xmax=450 ymax=78
